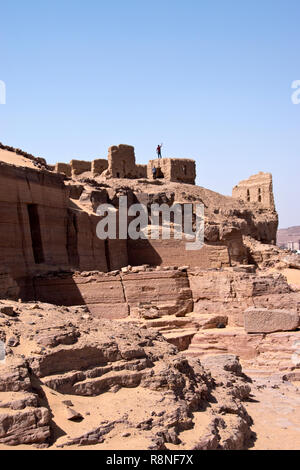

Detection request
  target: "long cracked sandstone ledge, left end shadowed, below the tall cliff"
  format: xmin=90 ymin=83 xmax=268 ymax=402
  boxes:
xmin=34 ymin=268 xmax=193 ymax=319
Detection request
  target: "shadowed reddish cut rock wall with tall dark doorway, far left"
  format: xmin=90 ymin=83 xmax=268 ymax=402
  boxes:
xmin=0 ymin=163 xmax=68 ymax=279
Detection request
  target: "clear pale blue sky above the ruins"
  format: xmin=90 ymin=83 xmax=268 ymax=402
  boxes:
xmin=0 ymin=0 xmax=300 ymax=227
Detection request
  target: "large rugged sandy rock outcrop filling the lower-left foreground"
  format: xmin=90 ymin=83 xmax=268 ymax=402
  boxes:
xmin=0 ymin=303 xmax=251 ymax=449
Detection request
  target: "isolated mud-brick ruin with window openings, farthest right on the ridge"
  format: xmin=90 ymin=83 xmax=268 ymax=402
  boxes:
xmin=232 ymin=172 xmax=275 ymax=211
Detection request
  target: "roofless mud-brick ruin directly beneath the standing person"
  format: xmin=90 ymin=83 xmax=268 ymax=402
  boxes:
xmin=147 ymin=158 xmax=196 ymax=184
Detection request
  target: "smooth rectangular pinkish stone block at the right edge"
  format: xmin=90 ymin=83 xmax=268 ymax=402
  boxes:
xmin=244 ymin=307 xmax=300 ymax=333
